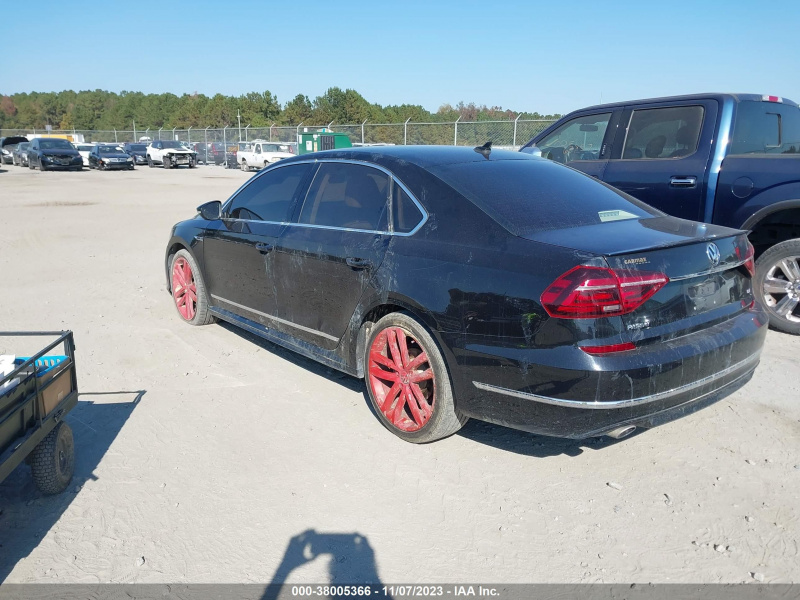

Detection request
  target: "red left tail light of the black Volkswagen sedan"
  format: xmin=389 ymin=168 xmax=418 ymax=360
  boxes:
xmin=541 ymin=266 xmax=669 ymax=319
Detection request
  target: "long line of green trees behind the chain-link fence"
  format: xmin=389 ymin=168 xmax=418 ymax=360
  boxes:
xmin=0 ymin=87 xmax=560 ymax=130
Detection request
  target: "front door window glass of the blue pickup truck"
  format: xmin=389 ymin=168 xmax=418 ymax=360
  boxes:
xmin=536 ymin=112 xmax=611 ymax=163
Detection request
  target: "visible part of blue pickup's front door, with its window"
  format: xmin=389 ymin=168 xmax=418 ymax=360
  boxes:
xmin=522 ymin=109 xmax=622 ymax=179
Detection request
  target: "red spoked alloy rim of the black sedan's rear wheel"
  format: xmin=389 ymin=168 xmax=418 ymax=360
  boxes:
xmin=369 ymin=327 xmax=436 ymax=432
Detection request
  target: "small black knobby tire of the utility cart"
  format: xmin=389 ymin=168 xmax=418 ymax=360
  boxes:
xmin=30 ymin=421 xmax=75 ymax=494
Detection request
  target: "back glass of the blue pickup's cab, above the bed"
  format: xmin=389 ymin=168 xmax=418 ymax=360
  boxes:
xmin=730 ymin=101 xmax=800 ymax=154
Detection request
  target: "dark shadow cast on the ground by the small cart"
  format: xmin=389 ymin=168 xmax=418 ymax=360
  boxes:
xmin=0 ymin=390 xmax=145 ymax=582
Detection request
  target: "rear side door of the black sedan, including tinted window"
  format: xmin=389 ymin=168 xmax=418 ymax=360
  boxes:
xmin=275 ymin=161 xmax=391 ymax=349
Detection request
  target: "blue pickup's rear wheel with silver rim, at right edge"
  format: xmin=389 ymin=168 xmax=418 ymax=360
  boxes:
xmin=754 ymin=239 xmax=800 ymax=335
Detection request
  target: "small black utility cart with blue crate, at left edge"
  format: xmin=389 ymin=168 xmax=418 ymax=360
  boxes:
xmin=0 ymin=331 xmax=78 ymax=494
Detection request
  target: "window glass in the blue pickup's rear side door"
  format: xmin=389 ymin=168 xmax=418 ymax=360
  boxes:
xmin=622 ymin=106 xmax=703 ymax=159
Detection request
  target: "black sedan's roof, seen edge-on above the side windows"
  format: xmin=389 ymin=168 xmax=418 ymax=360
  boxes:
xmin=281 ymin=146 xmax=533 ymax=168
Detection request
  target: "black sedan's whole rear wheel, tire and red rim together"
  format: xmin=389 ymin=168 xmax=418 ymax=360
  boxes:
xmin=364 ymin=312 xmax=468 ymax=444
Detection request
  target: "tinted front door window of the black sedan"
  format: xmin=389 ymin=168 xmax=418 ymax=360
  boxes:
xmin=227 ymin=164 xmax=311 ymax=223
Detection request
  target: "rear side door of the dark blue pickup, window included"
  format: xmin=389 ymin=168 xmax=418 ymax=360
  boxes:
xmin=602 ymin=100 xmax=717 ymax=221
